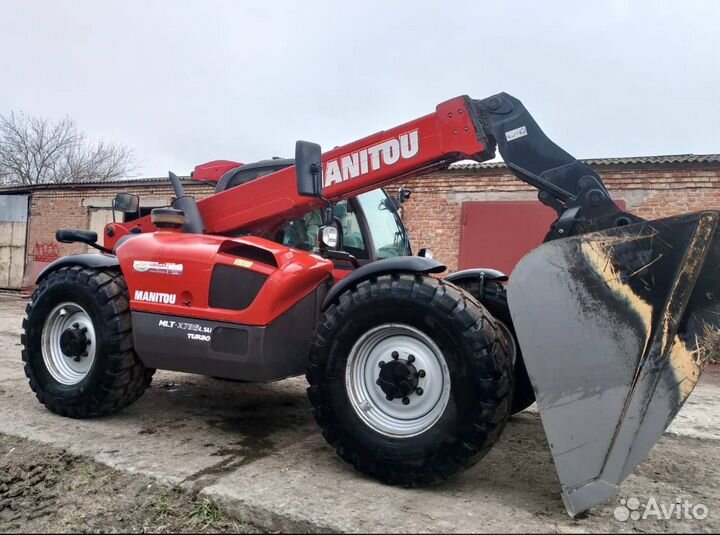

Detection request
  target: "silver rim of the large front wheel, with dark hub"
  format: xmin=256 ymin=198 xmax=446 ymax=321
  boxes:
xmin=345 ymin=323 xmax=450 ymax=438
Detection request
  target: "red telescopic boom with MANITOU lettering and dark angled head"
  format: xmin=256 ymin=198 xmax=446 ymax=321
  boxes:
xmin=105 ymin=93 xmax=640 ymax=240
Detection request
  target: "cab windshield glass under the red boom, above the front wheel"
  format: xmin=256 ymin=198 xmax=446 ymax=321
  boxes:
xmin=357 ymin=189 xmax=410 ymax=259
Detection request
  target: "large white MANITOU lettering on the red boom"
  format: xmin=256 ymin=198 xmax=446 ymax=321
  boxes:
xmin=323 ymin=130 xmax=420 ymax=188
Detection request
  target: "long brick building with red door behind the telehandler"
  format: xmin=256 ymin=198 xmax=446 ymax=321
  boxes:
xmin=0 ymin=154 xmax=720 ymax=288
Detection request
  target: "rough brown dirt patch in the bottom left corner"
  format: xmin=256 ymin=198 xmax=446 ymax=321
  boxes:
xmin=0 ymin=435 xmax=259 ymax=533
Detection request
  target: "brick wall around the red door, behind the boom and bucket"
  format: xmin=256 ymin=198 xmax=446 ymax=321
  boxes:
xmin=400 ymin=163 xmax=720 ymax=271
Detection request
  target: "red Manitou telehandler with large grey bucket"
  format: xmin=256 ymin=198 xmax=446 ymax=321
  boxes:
xmin=22 ymin=93 xmax=720 ymax=515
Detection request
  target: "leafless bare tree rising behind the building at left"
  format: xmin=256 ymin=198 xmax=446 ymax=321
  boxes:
xmin=0 ymin=112 xmax=137 ymax=186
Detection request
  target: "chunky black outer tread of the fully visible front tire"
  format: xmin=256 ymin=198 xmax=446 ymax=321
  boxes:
xmin=306 ymin=274 xmax=512 ymax=487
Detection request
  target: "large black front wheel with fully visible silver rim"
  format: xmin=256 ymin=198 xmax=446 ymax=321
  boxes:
xmin=307 ymin=274 xmax=512 ymax=486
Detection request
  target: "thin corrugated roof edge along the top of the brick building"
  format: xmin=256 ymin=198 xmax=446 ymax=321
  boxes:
xmin=0 ymin=154 xmax=720 ymax=193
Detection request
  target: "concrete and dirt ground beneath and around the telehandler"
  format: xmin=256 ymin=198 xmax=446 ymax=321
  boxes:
xmin=0 ymin=296 xmax=720 ymax=533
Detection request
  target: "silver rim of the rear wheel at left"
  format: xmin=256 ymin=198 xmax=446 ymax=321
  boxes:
xmin=41 ymin=302 xmax=97 ymax=385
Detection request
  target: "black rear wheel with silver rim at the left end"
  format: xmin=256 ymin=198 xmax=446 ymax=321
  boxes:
xmin=22 ymin=266 xmax=155 ymax=418
